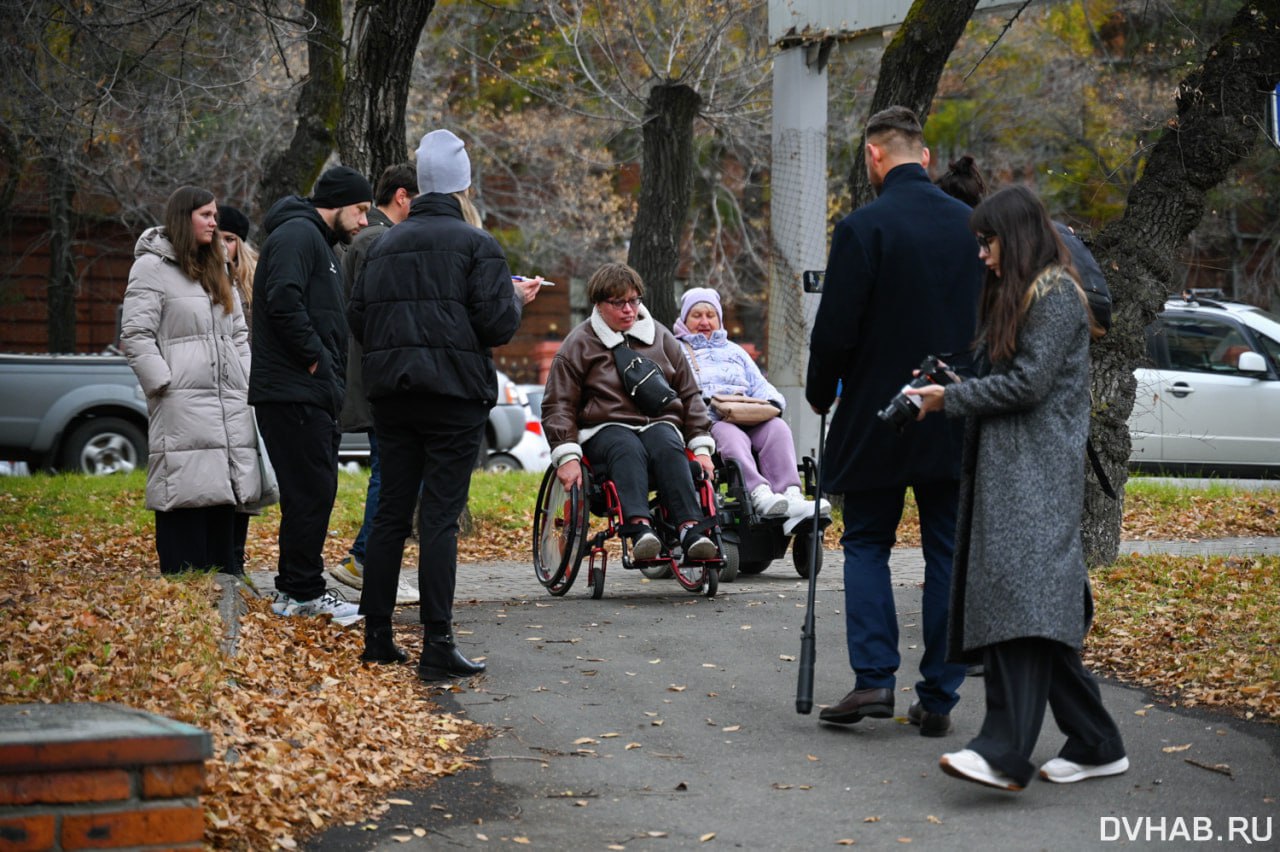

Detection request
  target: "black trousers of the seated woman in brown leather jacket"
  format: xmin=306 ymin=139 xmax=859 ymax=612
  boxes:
xmin=582 ymin=423 xmax=703 ymax=525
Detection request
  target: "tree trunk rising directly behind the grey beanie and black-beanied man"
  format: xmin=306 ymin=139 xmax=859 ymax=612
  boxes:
xmin=338 ymin=0 xmax=435 ymax=183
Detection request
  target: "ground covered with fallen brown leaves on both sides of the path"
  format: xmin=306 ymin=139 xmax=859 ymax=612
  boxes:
xmin=0 ymin=475 xmax=1280 ymax=849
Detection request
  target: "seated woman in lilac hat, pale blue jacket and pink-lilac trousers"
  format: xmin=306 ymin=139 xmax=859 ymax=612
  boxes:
xmin=675 ymin=287 xmax=831 ymax=518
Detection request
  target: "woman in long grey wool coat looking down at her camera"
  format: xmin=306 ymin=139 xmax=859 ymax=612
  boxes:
xmin=914 ymin=187 xmax=1129 ymax=791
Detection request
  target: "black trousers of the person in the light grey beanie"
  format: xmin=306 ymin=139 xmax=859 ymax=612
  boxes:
xmin=360 ymin=395 xmax=489 ymax=636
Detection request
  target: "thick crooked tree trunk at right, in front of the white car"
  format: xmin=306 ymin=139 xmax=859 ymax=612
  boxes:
xmin=1084 ymin=0 xmax=1280 ymax=565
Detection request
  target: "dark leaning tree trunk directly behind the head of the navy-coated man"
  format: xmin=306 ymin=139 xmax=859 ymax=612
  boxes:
xmin=849 ymin=0 xmax=978 ymax=210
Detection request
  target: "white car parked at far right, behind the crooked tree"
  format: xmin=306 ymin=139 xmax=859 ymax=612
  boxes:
xmin=1129 ymin=292 xmax=1280 ymax=477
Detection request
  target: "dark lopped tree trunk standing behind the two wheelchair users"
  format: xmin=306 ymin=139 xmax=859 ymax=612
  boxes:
xmin=627 ymin=83 xmax=703 ymax=327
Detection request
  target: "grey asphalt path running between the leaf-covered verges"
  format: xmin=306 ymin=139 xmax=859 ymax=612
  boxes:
xmin=285 ymin=539 xmax=1280 ymax=849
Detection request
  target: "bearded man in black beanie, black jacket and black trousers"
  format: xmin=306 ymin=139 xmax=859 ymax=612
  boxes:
xmin=248 ymin=166 xmax=374 ymax=626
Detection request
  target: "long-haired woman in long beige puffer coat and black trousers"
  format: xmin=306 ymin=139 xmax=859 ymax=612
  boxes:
xmin=120 ymin=187 xmax=261 ymax=574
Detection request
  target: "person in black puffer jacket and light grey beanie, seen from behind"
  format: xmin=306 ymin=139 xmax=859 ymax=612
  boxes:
xmin=347 ymin=130 xmax=541 ymax=681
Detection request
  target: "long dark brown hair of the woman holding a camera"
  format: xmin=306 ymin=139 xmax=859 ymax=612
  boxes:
xmin=969 ymin=185 xmax=1092 ymax=362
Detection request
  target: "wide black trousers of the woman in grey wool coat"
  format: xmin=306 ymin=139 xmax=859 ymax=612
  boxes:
xmin=969 ymin=638 xmax=1125 ymax=785
